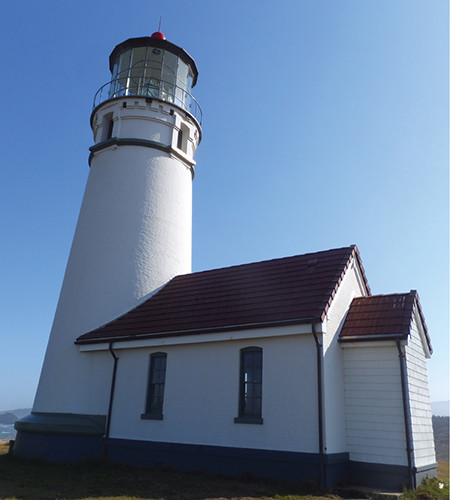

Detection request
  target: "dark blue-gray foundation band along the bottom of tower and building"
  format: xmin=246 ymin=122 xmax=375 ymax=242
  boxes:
xmin=13 ymin=431 xmax=437 ymax=491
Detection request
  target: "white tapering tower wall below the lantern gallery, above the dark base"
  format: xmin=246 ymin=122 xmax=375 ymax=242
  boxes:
xmin=33 ymin=97 xmax=200 ymax=414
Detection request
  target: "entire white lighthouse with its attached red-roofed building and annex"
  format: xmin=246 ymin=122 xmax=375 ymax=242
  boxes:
xmin=14 ymin=33 xmax=436 ymax=488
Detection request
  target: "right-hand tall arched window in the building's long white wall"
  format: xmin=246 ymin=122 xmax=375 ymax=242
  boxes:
xmin=234 ymin=347 xmax=263 ymax=424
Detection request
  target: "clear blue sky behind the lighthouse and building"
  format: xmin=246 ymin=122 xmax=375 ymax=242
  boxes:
xmin=0 ymin=0 xmax=449 ymax=410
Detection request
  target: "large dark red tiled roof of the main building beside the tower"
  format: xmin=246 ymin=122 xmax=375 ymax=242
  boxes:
xmin=76 ymin=245 xmax=370 ymax=344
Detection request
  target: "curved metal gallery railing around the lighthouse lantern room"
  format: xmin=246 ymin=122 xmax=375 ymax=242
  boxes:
xmin=93 ymin=77 xmax=203 ymax=125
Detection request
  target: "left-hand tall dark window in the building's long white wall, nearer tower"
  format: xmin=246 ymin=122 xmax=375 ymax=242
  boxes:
xmin=141 ymin=352 xmax=167 ymax=420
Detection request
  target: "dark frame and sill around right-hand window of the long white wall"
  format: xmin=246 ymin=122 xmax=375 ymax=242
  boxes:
xmin=234 ymin=346 xmax=264 ymax=424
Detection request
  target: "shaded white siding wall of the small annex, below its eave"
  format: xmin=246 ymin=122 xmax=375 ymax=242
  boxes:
xmin=344 ymin=344 xmax=408 ymax=465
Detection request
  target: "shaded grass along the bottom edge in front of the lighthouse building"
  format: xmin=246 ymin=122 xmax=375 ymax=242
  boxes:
xmin=0 ymin=442 xmax=449 ymax=500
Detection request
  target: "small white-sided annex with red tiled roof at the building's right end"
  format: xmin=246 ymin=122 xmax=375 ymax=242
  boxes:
xmin=340 ymin=291 xmax=436 ymax=485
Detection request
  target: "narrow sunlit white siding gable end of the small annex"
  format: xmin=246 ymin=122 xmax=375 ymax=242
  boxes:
xmin=405 ymin=320 xmax=436 ymax=467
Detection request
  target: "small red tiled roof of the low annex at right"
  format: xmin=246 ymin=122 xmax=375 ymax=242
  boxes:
xmin=339 ymin=290 xmax=432 ymax=352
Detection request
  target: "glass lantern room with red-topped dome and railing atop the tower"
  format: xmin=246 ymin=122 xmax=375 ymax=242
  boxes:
xmin=94 ymin=32 xmax=201 ymax=124
